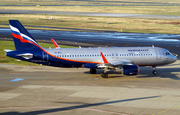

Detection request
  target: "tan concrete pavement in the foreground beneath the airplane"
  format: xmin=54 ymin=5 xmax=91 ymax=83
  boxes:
xmin=0 ymin=60 xmax=180 ymax=115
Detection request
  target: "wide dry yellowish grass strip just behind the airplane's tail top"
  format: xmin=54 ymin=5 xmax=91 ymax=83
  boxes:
xmin=0 ymin=14 xmax=180 ymax=34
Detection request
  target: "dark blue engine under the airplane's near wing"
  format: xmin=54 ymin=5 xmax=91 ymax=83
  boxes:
xmin=123 ymin=65 xmax=139 ymax=75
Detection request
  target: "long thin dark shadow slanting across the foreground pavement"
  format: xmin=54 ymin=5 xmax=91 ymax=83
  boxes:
xmin=2 ymin=96 xmax=160 ymax=115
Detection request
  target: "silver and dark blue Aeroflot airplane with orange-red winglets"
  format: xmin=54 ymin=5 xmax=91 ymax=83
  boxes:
xmin=6 ymin=20 xmax=177 ymax=78
